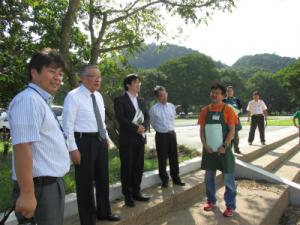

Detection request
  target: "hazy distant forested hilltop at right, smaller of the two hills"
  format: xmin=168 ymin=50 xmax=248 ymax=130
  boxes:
xmin=232 ymin=54 xmax=296 ymax=72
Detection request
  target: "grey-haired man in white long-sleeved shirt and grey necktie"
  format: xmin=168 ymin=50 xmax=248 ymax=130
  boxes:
xmin=63 ymin=65 xmax=120 ymax=225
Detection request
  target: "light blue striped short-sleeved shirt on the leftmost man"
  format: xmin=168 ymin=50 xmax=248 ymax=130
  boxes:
xmin=8 ymin=83 xmax=70 ymax=180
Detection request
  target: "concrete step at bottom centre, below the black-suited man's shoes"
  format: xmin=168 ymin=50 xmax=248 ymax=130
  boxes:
xmin=64 ymin=171 xmax=222 ymax=225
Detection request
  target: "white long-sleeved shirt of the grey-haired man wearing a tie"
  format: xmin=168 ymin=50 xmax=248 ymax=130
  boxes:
xmin=63 ymin=84 xmax=108 ymax=151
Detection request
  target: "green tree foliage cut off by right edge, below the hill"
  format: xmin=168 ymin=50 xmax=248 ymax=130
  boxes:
xmin=274 ymin=59 xmax=300 ymax=106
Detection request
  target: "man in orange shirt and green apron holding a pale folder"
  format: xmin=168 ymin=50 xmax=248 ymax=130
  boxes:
xmin=198 ymin=84 xmax=238 ymax=217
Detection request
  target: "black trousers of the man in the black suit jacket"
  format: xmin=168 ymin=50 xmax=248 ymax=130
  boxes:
xmin=120 ymin=142 xmax=145 ymax=196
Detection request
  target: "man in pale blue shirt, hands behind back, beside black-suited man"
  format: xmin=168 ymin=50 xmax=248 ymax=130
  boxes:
xmin=149 ymin=86 xmax=185 ymax=188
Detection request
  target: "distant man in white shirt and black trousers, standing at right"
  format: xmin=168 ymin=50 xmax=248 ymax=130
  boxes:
xmin=247 ymin=91 xmax=268 ymax=145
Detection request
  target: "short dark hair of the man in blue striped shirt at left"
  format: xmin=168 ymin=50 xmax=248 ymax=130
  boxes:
xmin=28 ymin=48 xmax=65 ymax=81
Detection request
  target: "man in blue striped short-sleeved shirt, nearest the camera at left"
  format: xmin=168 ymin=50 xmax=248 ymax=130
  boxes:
xmin=9 ymin=48 xmax=70 ymax=225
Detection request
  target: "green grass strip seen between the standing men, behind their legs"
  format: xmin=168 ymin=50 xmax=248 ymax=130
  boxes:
xmin=0 ymin=145 xmax=199 ymax=212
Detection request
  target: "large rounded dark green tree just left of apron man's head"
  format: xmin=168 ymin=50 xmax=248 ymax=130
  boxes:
xmin=158 ymin=54 xmax=219 ymax=113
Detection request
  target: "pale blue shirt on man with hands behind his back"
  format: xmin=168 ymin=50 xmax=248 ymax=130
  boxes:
xmin=149 ymin=102 xmax=176 ymax=133
